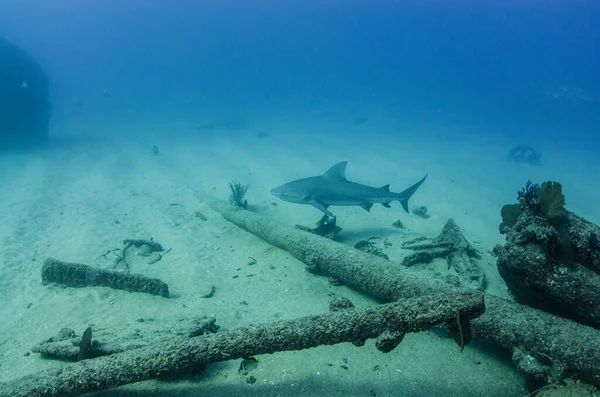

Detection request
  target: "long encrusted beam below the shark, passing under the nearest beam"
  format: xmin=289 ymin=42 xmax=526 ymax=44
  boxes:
xmin=203 ymin=197 xmax=600 ymax=385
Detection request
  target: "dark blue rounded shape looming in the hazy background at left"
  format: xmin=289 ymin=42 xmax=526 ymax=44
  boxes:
xmin=0 ymin=37 xmax=50 ymax=145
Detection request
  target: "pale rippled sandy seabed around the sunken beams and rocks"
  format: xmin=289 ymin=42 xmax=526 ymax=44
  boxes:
xmin=0 ymin=118 xmax=600 ymax=397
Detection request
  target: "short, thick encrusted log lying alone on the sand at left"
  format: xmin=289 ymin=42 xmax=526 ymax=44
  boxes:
xmin=42 ymin=258 xmax=169 ymax=298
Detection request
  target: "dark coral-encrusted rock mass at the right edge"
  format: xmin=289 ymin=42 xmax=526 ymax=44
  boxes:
xmin=494 ymin=182 xmax=600 ymax=329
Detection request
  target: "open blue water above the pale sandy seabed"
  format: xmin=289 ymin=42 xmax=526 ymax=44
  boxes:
xmin=0 ymin=0 xmax=600 ymax=150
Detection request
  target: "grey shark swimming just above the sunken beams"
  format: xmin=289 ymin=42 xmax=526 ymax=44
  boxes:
xmin=271 ymin=161 xmax=427 ymax=218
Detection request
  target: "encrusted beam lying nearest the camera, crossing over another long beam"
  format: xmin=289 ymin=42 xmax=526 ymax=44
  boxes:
xmin=0 ymin=293 xmax=485 ymax=397
